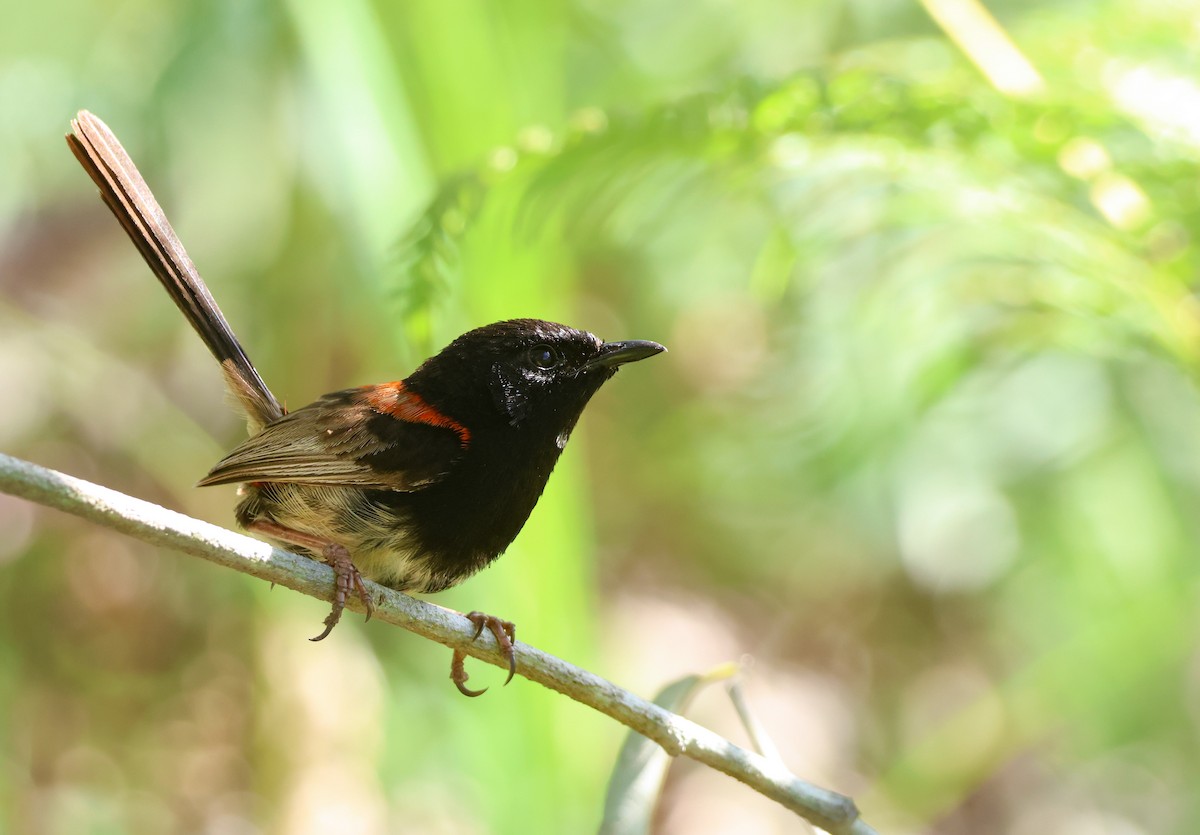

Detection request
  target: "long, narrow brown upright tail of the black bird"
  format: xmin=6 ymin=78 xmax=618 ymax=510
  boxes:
xmin=67 ymin=110 xmax=283 ymax=433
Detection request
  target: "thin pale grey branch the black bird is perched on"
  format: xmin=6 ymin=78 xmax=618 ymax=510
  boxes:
xmin=0 ymin=455 xmax=875 ymax=835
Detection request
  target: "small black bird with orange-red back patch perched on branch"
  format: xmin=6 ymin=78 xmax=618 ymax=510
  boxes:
xmin=66 ymin=110 xmax=666 ymax=696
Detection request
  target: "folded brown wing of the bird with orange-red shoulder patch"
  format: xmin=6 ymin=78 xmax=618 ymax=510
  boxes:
xmin=199 ymin=383 xmax=470 ymax=491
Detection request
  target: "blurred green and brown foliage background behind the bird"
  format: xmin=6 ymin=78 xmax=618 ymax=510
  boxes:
xmin=0 ymin=0 xmax=1200 ymax=835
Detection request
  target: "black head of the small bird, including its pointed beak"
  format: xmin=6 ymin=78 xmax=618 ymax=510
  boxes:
xmin=406 ymin=319 xmax=666 ymax=441
